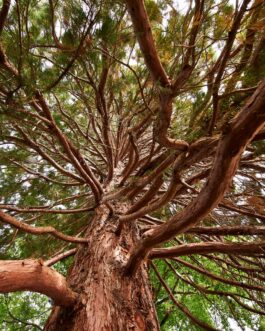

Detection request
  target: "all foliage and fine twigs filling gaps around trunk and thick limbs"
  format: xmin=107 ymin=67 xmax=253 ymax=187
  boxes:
xmin=0 ymin=0 xmax=265 ymax=331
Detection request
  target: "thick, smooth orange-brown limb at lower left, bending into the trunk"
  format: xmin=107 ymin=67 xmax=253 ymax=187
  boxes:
xmin=0 ymin=260 xmax=77 ymax=307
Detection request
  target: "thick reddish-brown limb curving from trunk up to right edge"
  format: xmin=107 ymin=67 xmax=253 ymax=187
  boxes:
xmin=127 ymin=80 xmax=265 ymax=273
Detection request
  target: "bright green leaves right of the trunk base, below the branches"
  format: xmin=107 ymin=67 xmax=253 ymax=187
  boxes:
xmin=150 ymin=257 xmax=264 ymax=331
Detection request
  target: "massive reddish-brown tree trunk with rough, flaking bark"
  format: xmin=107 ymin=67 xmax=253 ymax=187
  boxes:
xmin=44 ymin=206 xmax=159 ymax=331
